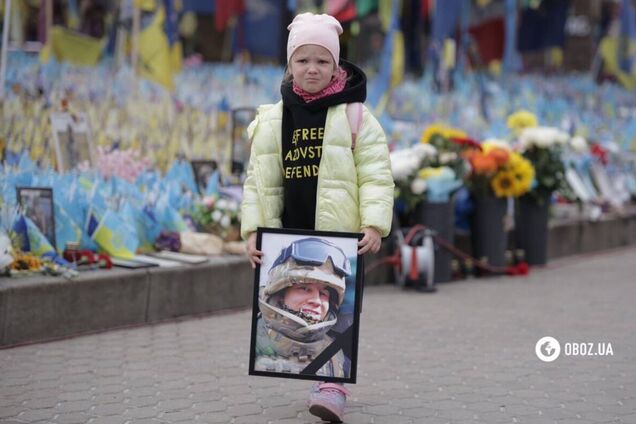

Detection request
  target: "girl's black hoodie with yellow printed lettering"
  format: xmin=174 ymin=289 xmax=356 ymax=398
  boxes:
xmin=280 ymin=59 xmax=367 ymax=230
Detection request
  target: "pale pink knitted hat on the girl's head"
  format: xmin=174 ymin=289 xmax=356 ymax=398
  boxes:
xmin=287 ymin=13 xmax=342 ymax=65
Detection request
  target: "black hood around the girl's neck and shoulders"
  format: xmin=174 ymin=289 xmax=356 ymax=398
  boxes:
xmin=280 ymin=59 xmax=367 ymax=111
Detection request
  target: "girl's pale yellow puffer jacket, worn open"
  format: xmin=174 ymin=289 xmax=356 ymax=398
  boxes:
xmin=241 ymin=101 xmax=393 ymax=239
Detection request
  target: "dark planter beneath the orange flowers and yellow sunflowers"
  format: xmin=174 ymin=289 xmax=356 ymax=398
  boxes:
xmin=470 ymin=197 xmax=507 ymax=267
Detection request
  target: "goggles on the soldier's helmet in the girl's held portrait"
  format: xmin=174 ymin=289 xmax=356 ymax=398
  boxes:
xmin=272 ymin=237 xmax=351 ymax=277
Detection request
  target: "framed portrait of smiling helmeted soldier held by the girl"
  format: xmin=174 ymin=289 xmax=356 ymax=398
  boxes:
xmin=249 ymin=228 xmax=362 ymax=383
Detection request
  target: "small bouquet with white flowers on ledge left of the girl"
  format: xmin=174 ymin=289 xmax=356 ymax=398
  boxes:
xmin=192 ymin=196 xmax=241 ymax=241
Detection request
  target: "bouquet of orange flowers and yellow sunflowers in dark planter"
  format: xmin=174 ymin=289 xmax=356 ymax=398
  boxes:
xmin=464 ymin=140 xmax=535 ymax=197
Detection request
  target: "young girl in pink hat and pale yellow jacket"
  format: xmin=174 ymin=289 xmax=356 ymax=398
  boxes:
xmin=241 ymin=13 xmax=393 ymax=422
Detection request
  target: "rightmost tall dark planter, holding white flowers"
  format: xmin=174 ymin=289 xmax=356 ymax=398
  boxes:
xmin=515 ymin=196 xmax=550 ymax=265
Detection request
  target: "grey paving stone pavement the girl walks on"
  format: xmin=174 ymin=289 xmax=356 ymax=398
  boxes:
xmin=0 ymin=248 xmax=636 ymax=424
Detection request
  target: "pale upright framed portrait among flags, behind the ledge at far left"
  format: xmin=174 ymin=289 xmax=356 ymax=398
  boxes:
xmin=51 ymin=112 xmax=95 ymax=172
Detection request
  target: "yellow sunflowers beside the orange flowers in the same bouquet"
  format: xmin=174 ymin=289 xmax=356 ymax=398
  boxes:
xmin=490 ymin=152 xmax=534 ymax=197
